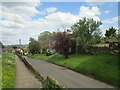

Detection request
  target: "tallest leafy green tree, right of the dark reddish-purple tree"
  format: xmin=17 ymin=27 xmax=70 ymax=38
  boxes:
xmin=71 ymin=18 xmax=102 ymax=53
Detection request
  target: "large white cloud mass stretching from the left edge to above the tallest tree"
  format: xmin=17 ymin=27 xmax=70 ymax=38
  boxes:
xmin=0 ymin=2 xmax=101 ymax=44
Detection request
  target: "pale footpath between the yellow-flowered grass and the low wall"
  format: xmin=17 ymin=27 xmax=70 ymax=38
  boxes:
xmin=15 ymin=56 xmax=42 ymax=88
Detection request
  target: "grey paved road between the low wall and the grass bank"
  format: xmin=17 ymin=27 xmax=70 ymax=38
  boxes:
xmin=25 ymin=57 xmax=113 ymax=88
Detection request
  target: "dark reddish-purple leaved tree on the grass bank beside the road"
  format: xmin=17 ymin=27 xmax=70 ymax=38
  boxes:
xmin=54 ymin=32 xmax=70 ymax=58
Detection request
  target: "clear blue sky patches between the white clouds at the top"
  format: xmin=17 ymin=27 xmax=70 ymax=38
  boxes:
xmin=33 ymin=2 xmax=118 ymax=25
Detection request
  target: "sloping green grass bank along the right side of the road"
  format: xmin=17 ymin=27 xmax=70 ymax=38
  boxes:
xmin=29 ymin=54 xmax=120 ymax=86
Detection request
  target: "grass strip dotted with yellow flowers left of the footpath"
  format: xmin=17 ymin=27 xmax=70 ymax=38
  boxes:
xmin=2 ymin=53 xmax=16 ymax=88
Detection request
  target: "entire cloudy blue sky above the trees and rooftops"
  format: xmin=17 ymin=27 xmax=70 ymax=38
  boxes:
xmin=0 ymin=0 xmax=120 ymax=45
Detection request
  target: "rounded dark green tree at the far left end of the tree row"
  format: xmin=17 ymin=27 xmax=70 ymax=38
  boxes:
xmin=28 ymin=38 xmax=40 ymax=54
